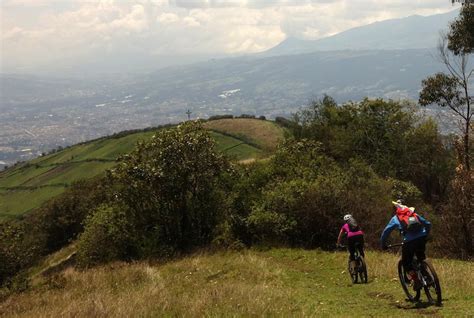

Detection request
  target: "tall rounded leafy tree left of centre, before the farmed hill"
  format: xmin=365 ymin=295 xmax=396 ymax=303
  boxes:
xmin=77 ymin=122 xmax=228 ymax=265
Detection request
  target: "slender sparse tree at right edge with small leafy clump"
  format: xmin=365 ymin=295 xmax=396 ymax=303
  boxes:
xmin=419 ymin=35 xmax=474 ymax=171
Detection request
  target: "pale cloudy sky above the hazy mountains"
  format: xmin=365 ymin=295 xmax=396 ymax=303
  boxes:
xmin=0 ymin=0 xmax=462 ymax=73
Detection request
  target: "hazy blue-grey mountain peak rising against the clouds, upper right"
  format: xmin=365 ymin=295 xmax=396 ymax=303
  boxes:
xmin=263 ymin=10 xmax=459 ymax=56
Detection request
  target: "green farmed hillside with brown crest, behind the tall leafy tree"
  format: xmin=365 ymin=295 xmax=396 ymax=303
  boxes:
xmin=0 ymin=119 xmax=282 ymax=220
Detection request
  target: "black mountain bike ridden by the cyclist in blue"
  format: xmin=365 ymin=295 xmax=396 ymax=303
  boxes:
xmin=388 ymin=243 xmax=442 ymax=306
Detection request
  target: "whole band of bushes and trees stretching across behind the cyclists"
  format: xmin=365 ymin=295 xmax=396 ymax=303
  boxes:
xmin=0 ymin=97 xmax=474 ymax=283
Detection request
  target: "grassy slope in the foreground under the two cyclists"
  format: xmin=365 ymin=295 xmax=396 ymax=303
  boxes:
xmin=0 ymin=249 xmax=474 ymax=317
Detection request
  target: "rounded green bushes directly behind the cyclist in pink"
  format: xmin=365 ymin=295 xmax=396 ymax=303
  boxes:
xmin=239 ymin=139 xmax=390 ymax=248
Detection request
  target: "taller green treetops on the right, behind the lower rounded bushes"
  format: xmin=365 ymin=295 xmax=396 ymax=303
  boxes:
xmin=293 ymin=96 xmax=450 ymax=200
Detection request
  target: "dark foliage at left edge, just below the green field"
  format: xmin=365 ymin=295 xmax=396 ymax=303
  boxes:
xmin=0 ymin=179 xmax=106 ymax=285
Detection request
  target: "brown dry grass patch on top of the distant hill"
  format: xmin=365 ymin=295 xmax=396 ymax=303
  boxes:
xmin=204 ymin=118 xmax=284 ymax=150
